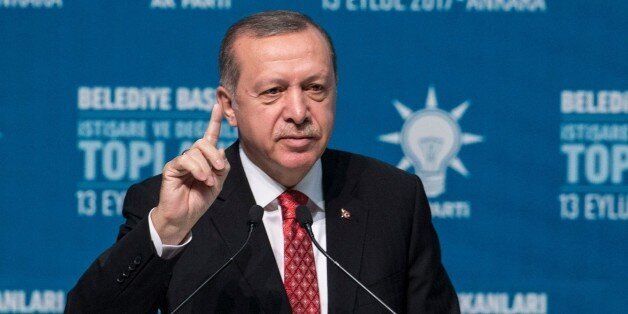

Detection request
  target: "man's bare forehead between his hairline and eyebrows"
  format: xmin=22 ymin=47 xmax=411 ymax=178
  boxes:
xmin=233 ymin=27 xmax=333 ymax=78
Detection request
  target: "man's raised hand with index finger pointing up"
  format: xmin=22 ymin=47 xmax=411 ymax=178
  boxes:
xmin=151 ymin=104 xmax=230 ymax=245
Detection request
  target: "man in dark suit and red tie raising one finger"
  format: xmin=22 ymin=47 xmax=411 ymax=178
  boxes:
xmin=66 ymin=11 xmax=459 ymax=313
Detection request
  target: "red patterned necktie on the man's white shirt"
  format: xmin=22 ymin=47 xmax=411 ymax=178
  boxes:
xmin=278 ymin=190 xmax=321 ymax=313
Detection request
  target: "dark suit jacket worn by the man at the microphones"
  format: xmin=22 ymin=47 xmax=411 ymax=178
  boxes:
xmin=66 ymin=143 xmax=459 ymax=313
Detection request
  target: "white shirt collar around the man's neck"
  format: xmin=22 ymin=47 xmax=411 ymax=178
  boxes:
xmin=239 ymin=147 xmax=325 ymax=209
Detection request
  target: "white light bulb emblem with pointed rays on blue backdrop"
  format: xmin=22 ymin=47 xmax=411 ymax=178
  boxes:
xmin=379 ymin=86 xmax=483 ymax=197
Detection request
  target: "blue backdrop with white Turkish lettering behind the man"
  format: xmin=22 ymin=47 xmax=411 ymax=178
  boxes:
xmin=0 ymin=0 xmax=628 ymax=313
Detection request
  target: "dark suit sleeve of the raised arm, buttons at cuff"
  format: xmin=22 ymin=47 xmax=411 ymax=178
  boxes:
xmin=65 ymin=185 xmax=178 ymax=313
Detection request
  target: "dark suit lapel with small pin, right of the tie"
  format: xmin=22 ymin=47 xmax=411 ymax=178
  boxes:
xmin=321 ymin=149 xmax=368 ymax=312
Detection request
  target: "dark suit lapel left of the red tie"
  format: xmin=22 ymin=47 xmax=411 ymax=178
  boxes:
xmin=210 ymin=143 xmax=289 ymax=312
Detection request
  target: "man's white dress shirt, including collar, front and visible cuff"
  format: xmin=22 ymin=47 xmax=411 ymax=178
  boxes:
xmin=148 ymin=147 xmax=328 ymax=314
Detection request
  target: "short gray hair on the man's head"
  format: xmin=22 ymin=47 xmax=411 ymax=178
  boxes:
xmin=218 ymin=10 xmax=338 ymax=95
